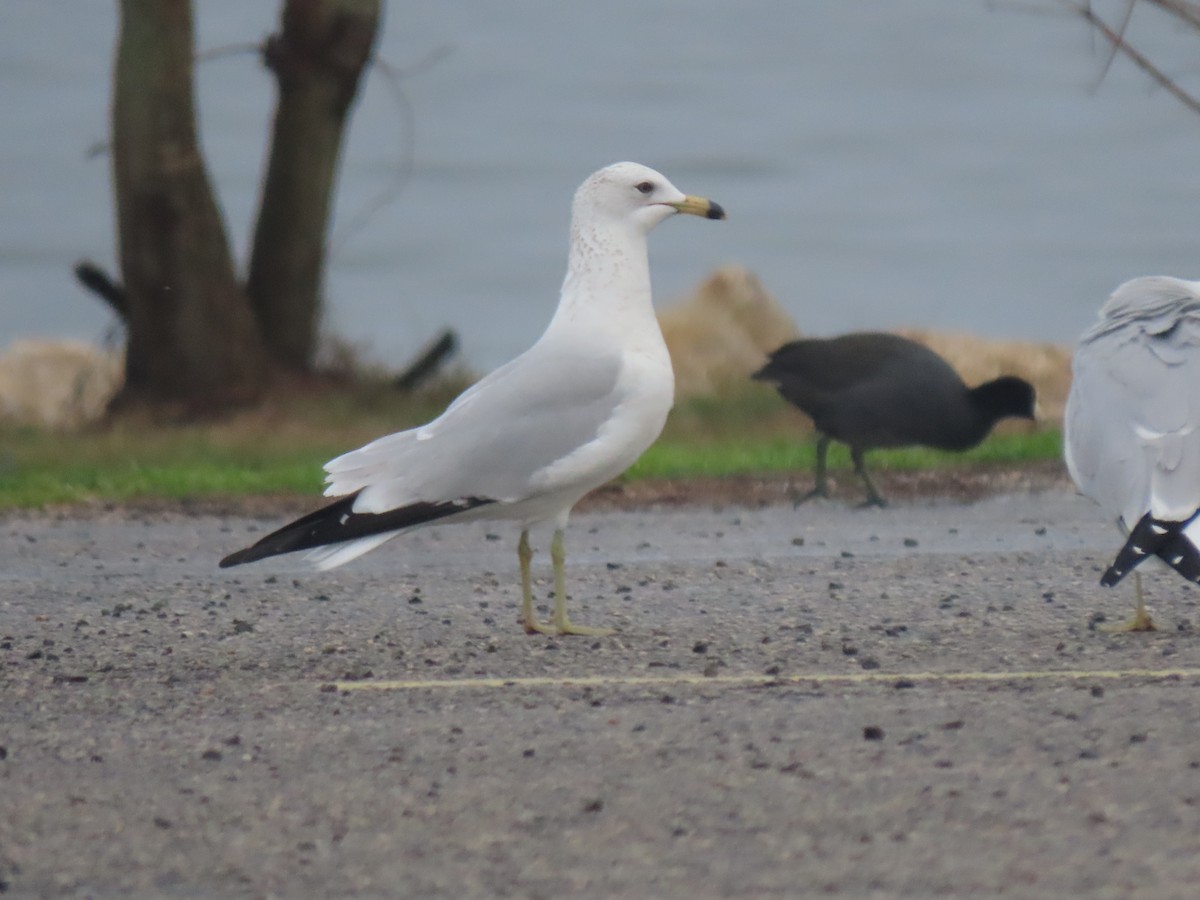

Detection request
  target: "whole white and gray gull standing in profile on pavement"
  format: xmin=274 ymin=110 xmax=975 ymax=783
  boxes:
xmin=221 ymin=162 xmax=725 ymax=635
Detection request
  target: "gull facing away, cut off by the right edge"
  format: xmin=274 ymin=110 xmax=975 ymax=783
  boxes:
xmin=1063 ymin=275 xmax=1200 ymax=631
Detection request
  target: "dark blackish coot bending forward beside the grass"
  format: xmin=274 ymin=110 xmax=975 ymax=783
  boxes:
xmin=752 ymin=332 xmax=1034 ymax=506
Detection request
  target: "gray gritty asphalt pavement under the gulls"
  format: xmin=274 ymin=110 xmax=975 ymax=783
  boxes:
xmin=0 ymin=491 xmax=1200 ymax=898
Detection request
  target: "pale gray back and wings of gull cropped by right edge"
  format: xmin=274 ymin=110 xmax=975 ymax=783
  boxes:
xmin=1064 ymin=314 xmax=1200 ymax=528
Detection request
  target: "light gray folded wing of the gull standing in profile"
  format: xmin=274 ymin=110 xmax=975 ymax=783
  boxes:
xmin=325 ymin=342 xmax=622 ymax=512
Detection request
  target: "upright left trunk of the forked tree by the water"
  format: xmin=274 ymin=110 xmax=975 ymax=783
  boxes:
xmin=112 ymin=0 xmax=265 ymax=412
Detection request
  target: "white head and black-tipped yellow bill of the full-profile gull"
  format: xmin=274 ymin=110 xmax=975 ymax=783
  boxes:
xmin=572 ymin=162 xmax=725 ymax=234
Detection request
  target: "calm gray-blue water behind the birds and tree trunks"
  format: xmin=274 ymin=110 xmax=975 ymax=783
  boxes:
xmin=0 ymin=0 xmax=1200 ymax=368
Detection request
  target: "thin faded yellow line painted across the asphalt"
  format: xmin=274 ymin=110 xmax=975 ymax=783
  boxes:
xmin=334 ymin=668 xmax=1200 ymax=691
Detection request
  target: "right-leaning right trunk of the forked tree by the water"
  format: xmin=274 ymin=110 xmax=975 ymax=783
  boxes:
xmin=246 ymin=0 xmax=382 ymax=370
